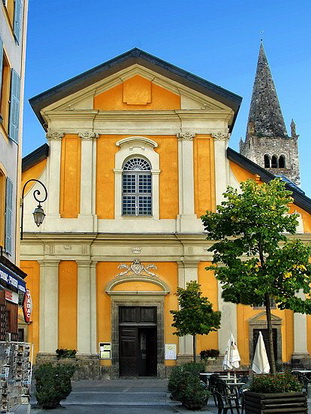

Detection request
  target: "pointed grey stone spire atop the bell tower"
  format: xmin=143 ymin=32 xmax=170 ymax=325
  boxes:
xmin=247 ymin=43 xmax=287 ymax=138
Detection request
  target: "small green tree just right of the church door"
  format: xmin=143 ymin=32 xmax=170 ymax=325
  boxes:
xmin=171 ymin=280 xmax=221 ymax=362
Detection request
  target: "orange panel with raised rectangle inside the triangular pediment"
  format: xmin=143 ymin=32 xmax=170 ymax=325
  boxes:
xmin=94 ymin=75 xmax=180 ymax=111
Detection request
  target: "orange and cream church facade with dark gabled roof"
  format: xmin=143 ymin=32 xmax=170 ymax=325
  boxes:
xmin=21 ymin=49 xmax=311 ymax=378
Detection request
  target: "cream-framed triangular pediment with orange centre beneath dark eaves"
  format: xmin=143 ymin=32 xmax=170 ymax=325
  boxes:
xmin=39 ymin=65 xmax=229 ymax=111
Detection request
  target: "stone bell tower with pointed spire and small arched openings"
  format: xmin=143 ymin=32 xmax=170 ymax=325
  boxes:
xmin=240 ymin=42 xmax=300 ymax=185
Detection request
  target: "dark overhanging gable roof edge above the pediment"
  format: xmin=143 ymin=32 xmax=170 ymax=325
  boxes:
xmin=29 ymin=48 xmax=242 ymax=129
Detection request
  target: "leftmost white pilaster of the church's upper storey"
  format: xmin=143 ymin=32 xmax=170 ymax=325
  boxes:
xmin=46 ymin=131 xmax=64 ymax=218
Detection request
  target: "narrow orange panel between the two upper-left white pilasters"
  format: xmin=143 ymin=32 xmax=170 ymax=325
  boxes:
xmin=60 ymin=135 xmax=81 ymax=218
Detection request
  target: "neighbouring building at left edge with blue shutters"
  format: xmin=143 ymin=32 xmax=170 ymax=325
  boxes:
xmin=0 ymin=0 xmax=28 ymax=341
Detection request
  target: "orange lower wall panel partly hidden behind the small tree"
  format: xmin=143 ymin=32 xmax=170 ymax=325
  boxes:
xmin=197 ymin=262 xmax=218 ymax=353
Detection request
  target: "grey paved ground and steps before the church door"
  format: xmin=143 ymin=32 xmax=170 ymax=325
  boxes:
xmin=16 ymin=378 xmax=311 ymax=414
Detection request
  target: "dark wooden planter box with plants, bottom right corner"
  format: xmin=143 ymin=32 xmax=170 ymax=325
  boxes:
xmin=243 ymin=372 xmax=308 ymax=414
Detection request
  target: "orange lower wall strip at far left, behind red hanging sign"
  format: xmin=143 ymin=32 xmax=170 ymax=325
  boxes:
xmin=20 ymin=260 xmax=40 ymax=358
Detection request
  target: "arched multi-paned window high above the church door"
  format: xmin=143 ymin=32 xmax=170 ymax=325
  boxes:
xmin=122 ymin=158 xmax=152 ymax=216
